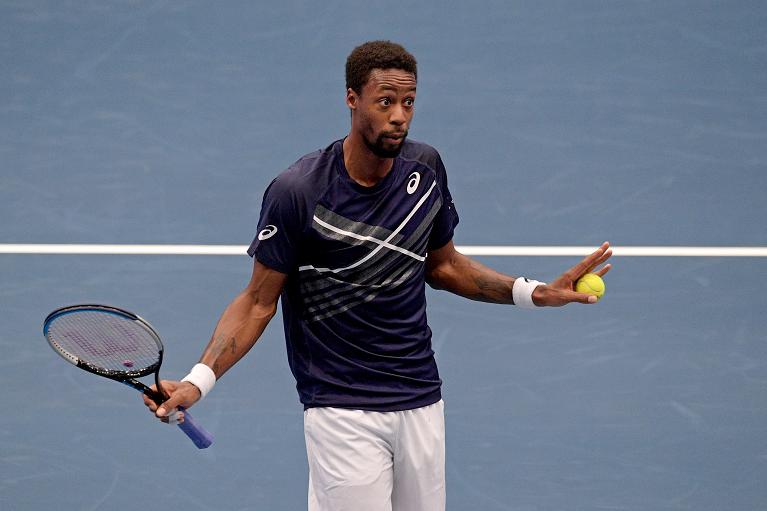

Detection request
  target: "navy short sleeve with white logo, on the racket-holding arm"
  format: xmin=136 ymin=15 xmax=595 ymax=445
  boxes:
xmin=248 ymin=176 xmax=306 ymax=273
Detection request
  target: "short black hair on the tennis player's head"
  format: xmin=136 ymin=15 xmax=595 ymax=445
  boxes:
xmin=346 ymin=41 xmax=418 ymax=94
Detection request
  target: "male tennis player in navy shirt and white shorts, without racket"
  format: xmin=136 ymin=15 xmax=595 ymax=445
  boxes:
xmin=145 ymin=41 xmax=611 ymax=511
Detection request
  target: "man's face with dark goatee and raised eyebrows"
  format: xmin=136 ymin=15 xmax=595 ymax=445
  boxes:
xmin=346 ymin=69 xmax=416 ymax=158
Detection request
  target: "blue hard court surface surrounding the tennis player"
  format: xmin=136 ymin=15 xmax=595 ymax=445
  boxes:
xmin=0 ymin=0 xmax=767 ymax=511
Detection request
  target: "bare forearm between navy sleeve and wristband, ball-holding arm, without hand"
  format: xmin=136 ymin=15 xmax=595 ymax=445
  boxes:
xmin=426 ymin=252 xmax=514 ymax=304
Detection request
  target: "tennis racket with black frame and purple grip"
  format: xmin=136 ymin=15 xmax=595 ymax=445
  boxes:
xmin=43 ymin=305 xmax=213 ymax=449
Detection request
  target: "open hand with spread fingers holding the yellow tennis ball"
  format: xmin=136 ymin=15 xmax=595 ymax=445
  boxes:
xmin=533 ymin=241 xmax=613 ymax=307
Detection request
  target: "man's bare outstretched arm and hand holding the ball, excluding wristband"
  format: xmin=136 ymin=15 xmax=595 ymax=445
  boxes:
xmin=426 ymin=241 xmax=612 ymax=307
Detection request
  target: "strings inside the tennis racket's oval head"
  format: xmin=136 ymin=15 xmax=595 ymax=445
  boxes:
xmin=48 ymin=311 xmax=160 ymax=372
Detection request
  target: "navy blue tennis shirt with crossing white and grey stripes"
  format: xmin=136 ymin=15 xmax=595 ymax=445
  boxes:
xmin=248 ymin=140 xmax=458 ymax=411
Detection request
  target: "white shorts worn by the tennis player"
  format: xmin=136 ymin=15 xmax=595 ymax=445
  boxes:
xmin=304 ymin=401 xmax=445 ymax=511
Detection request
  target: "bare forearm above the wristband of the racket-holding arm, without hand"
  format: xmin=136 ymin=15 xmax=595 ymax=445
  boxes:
xmin=200 ymin=291 xmax=277 ymax=378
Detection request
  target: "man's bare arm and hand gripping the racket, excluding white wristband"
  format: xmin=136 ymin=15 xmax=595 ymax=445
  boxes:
xmin=144 ymin=261 xmax=287 ymax=417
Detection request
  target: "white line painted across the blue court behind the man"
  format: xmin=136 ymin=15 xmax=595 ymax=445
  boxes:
xmin=0 ymin=243 xmax=767 ymax=257
